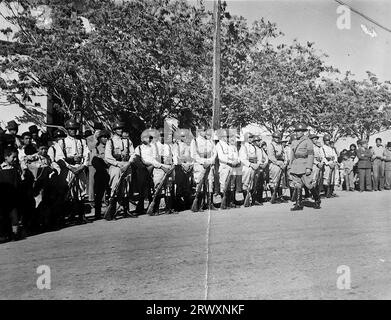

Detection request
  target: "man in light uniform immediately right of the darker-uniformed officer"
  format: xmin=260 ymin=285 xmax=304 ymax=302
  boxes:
xmin=321 ymin=134 xmax=338 ymax=198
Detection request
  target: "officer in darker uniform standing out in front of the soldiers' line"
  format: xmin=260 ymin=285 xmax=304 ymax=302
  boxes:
xmin=290 ymin=123 xmax=321 ymax=211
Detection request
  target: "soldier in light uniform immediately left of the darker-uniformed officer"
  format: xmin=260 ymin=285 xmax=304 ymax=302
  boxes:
xmin=267 ymin=131 xmax=288 ymax=203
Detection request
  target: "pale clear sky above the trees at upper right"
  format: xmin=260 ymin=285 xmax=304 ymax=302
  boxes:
xmin=196 ymin=0 xmax=391 ymax=81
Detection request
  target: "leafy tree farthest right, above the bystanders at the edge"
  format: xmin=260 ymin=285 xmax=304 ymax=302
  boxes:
xmin=313 ymin=71 xmax=391 ymax=140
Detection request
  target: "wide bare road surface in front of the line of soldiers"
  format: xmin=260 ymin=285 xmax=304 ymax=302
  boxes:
xmin=0 ymin=191 xmax=391 ymax=299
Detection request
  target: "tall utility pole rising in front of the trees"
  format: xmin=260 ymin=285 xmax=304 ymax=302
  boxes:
xmin=212 ymin=0 xmax=221 ymax=130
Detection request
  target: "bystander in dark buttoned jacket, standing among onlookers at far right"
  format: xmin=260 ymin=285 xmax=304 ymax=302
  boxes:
xmin=357 ymin=140 xmax=373 ymax=192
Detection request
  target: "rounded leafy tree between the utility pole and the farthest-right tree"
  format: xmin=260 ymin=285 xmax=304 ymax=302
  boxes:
xmin=242 ymin=41 xmax=332 ymax=133
